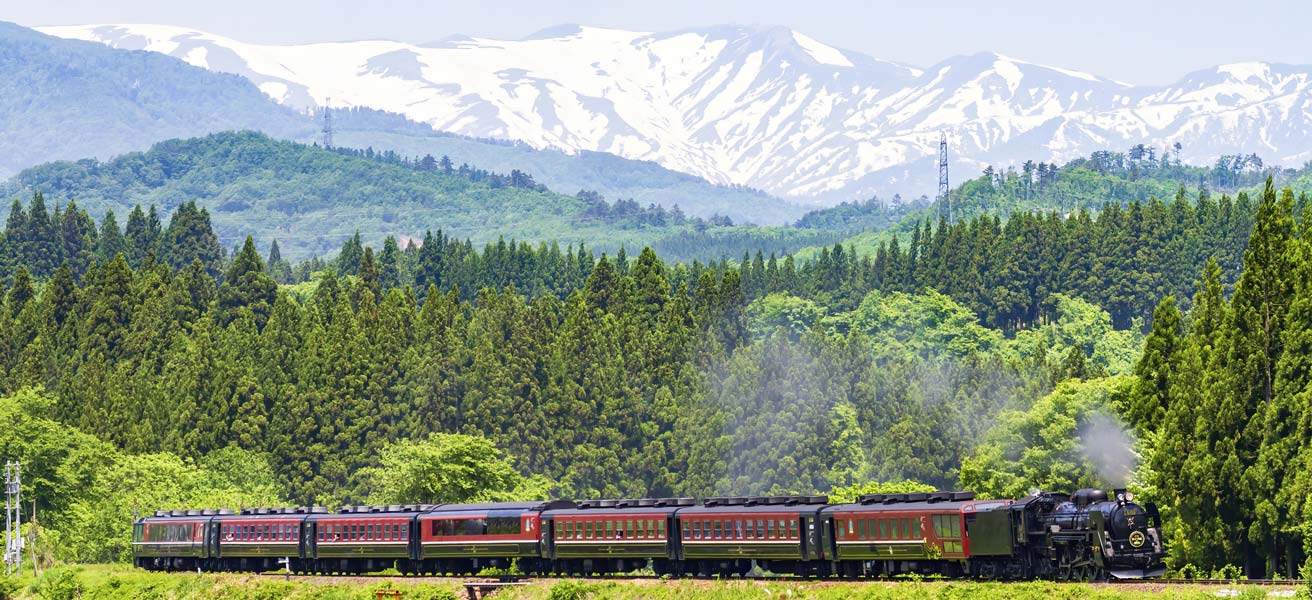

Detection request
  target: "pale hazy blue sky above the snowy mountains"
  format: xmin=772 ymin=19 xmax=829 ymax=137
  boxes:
xmin=10 ymin=0 xmax=1312 ymax=84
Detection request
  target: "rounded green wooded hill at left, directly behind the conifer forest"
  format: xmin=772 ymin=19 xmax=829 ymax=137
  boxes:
xmin=0 ymin=131 xmax=836 ymax=261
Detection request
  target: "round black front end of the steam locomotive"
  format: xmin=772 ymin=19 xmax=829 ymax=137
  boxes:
xmin=1089 ymin=490 xmax=1166 ymax=579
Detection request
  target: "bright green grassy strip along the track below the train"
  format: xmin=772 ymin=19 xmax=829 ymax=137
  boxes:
xmin=0 ymin=566 xmax=1308 ymax=600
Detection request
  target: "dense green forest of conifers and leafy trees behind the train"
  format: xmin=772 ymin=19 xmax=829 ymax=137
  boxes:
xmin=0 ymin=175 xmax=1312 ymax=572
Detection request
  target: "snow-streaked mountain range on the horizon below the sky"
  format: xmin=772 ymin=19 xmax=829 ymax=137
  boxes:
xmin=41 ymin=25 xmax=1312 ymax=200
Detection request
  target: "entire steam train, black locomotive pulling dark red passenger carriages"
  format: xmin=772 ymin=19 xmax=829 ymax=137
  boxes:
xmin=133 ymin=490 xmax=1165 ymax=580
